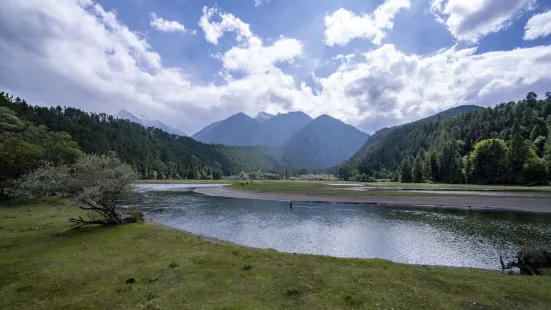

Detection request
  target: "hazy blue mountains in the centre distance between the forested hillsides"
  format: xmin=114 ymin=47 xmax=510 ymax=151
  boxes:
xmin=192 ymin=112 xmax=369 ymax=169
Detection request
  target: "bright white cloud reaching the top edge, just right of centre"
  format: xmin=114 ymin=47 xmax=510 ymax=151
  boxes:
xmin=325 ymin=0 xmax=410 ymax=46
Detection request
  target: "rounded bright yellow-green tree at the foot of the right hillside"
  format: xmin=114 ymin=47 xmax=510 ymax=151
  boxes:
xmin=469 ymin=139 xmax=509 ymax=184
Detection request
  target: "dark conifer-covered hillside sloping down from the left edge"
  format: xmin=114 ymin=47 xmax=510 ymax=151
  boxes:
xmin=0 ymin=93 xmax=280 ymax=179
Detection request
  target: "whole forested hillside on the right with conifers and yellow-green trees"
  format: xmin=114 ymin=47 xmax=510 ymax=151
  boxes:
xmin=340 ymin=92 xmax=551 ymax=184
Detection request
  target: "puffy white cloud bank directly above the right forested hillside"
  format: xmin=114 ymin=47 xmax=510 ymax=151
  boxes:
xmin=319 ymin=45 xmax=551 ymax=128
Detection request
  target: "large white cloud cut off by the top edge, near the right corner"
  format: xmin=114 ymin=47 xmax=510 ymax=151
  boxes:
xmin=431 ymin=0 xmax=536 ymax=43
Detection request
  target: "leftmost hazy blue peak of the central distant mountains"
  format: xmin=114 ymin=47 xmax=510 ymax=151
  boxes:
xmin=192 ymin=113 xmax=260 ymax=146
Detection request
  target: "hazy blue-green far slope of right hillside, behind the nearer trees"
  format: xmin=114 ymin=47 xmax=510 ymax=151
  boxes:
xmin=345 ymin=105 xmax=484 ymax=173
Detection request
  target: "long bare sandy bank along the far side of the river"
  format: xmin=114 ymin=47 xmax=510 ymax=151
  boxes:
xmin=195 ymin=187 xmax=551 ymax=213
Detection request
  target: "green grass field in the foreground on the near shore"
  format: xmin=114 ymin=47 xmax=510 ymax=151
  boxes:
xmin=0 ymin=199 xmax=551 ymax=309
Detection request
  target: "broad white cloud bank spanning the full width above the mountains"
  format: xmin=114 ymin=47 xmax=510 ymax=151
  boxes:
xmin=0 ymin=0 xmax=551 ymax=133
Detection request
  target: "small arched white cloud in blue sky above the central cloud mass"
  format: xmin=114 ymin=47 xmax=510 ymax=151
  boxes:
xmin=199 ymin=6 xmax=252 ymax=44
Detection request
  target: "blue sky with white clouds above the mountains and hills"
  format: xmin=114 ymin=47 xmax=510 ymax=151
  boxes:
xmin=0 ymin=0 xmax=551 ymax=133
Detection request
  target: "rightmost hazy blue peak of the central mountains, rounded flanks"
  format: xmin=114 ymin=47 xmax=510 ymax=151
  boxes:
xmin=282 ymin=115 xmax=369 ymax=169
